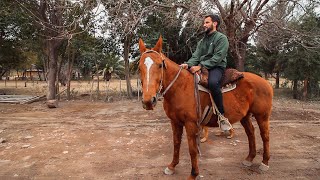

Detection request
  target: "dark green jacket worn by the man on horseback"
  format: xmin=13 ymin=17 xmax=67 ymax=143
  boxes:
xmin=186 ymin=31 xmax=229 ymax=69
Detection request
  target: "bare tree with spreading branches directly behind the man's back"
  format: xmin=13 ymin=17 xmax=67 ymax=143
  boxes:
xmin=206 ymin=0 xmax=276 ymax=71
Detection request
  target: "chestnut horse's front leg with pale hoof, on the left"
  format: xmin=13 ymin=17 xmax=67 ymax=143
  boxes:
xmin=164 ymin=121 xmax=183 ymax=175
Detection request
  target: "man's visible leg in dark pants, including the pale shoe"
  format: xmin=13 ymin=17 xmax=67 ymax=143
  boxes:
xmin=208 ymin=67 xmax=232 ymax=130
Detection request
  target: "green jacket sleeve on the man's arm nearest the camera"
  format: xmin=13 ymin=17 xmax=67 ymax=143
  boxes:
xmin=200 ymin=36 xmax=229 ymax=69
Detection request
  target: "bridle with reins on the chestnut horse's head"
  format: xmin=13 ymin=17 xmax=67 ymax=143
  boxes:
xmin=141 ymin=49 xmax=182 ymax=97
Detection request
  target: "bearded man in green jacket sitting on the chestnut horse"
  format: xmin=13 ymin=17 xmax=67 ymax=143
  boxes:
xmin=180 ymin=15 xmax=232 ymax=131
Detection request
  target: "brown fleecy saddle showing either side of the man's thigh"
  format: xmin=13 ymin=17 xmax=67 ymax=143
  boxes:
xmin=198 ymin=67 xmax=244 ymax=88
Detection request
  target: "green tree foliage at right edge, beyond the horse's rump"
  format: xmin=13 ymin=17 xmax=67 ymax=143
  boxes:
xmin=247 ymin=2 xmax=320 ymax=97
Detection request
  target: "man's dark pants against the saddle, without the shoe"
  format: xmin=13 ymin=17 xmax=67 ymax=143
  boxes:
xmin=208 ymin=67 xmax=225 ymax=114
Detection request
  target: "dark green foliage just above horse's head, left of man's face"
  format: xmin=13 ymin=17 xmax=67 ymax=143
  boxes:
xmin=138 ymin=9 xmax=202 ymax=64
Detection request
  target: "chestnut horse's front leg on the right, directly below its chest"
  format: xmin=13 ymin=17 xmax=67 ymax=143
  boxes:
xmin=185 ymin=121 xmax=200 ymax=179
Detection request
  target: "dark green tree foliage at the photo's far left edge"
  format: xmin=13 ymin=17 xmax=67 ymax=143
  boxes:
xmin=0 ymin=0 xmax=36 ymax=77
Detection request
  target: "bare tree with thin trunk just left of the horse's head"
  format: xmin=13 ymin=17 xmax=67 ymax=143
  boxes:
xmin=101 ymin=0 xmax=208 ymax=98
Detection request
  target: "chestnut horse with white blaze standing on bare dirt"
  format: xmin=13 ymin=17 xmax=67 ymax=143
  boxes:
xmin=139 ymin=37 xmax=273 ymax=179
